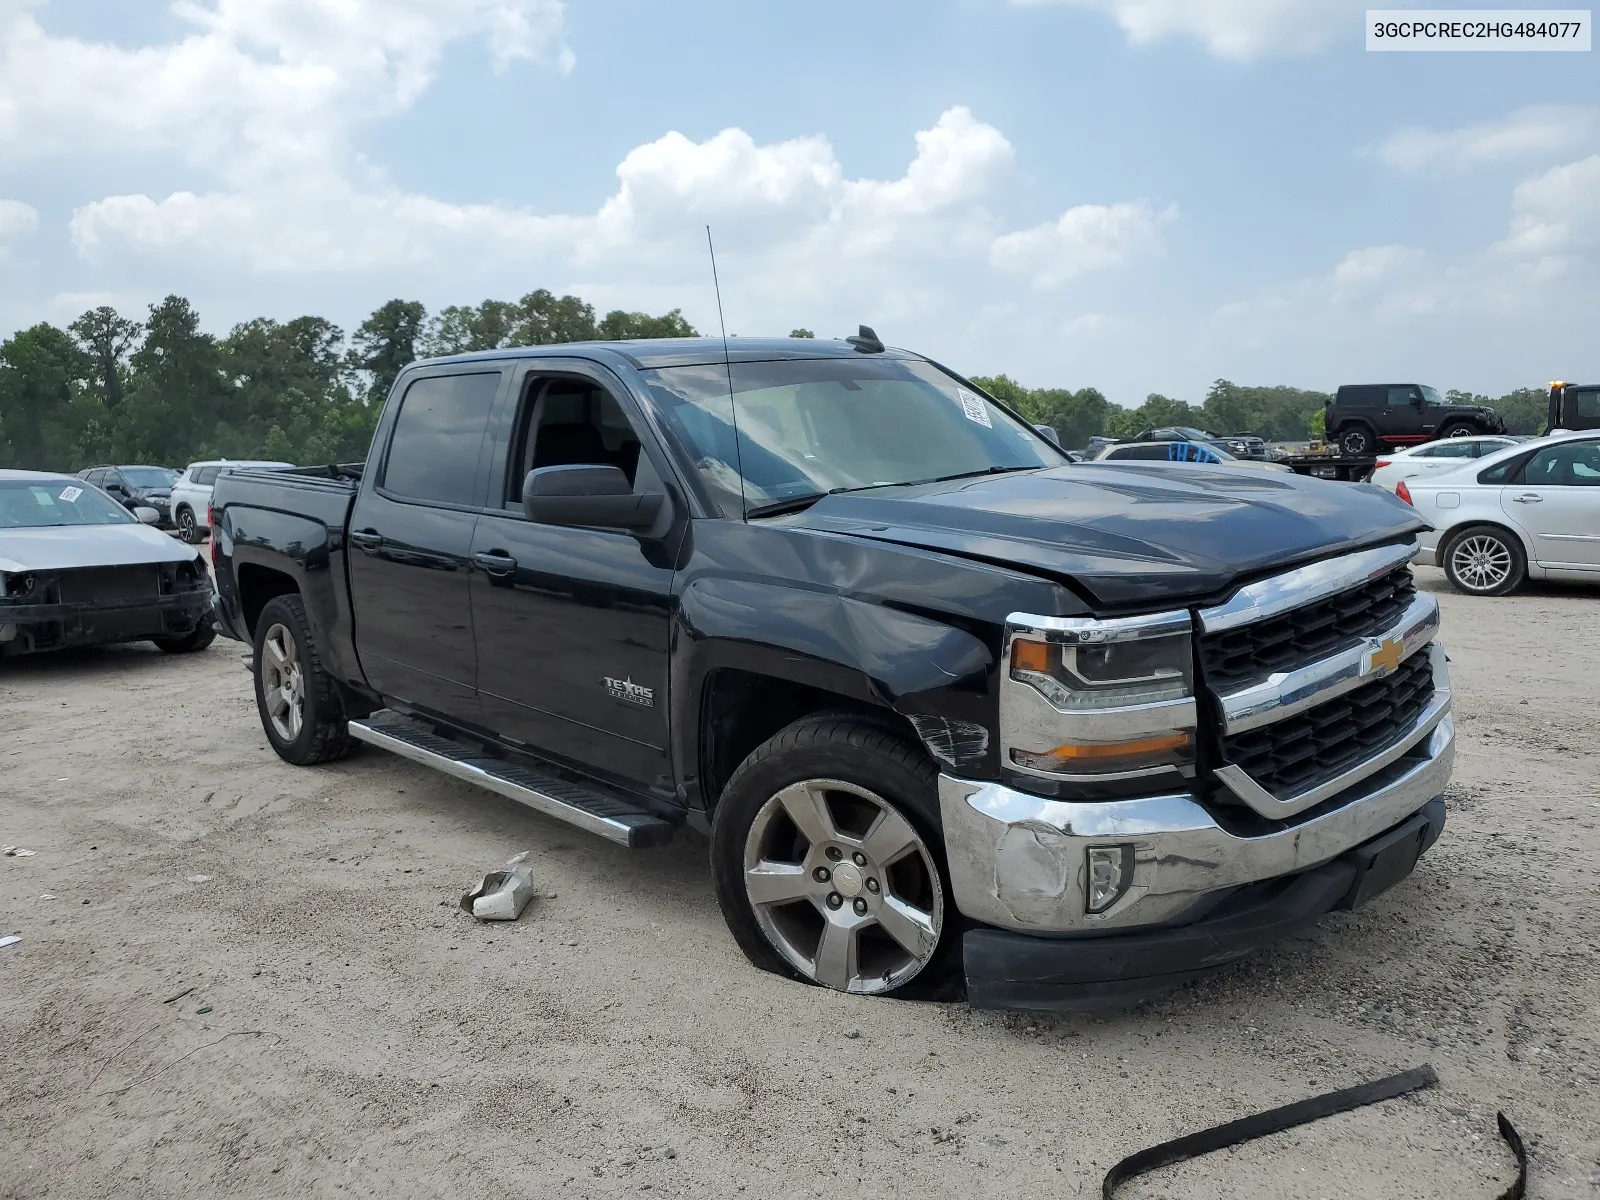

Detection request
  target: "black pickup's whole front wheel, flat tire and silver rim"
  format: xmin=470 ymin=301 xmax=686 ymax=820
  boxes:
xmin=712 ymin=714 xmax=960 ymax=998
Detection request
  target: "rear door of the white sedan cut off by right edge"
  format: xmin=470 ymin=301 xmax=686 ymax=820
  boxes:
xmin=1501 ymin=438 xmax=1600 ymax=571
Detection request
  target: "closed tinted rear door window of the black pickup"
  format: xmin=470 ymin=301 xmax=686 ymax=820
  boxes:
xmin=382 ymin=371 xmax=501 ymax=504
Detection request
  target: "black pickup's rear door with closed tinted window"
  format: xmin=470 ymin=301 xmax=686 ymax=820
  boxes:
xmin=347 ymin=363 xmax=502 ymax=723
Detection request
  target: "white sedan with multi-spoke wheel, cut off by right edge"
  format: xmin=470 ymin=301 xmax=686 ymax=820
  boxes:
xmin=1395 ymin=429 xmax=1600 ymax=595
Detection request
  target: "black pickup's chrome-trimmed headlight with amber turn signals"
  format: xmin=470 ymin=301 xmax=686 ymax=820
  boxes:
xmin=1000 ymin=611 xmax=1195 ymax=781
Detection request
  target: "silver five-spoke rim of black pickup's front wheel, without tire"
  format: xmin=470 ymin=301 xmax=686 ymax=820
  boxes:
xmin=744 ymin=779 xmax=944 ymax=995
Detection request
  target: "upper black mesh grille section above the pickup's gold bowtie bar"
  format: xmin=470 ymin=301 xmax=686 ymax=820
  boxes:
xmin=1198 ymin=565 xmax=1416 ymax=693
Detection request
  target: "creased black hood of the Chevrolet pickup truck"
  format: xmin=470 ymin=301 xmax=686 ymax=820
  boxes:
xmin=792 ymin=462 xmax=1427 ymax=610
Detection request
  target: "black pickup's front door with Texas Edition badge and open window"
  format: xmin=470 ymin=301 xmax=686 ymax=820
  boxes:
xmin=472 ymin=360 xmax=672 ymax=790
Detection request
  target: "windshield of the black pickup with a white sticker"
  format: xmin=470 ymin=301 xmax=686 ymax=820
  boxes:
xmin=643 ymin=357 xmax=1067 ymax=517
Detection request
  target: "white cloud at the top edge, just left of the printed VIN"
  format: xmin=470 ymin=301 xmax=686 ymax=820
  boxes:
xmin=1013 ymin=0 xmax=1366 ymax=59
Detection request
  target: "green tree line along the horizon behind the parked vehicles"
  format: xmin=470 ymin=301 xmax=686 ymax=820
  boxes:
xmin=0 ymin=288 xmax=1546 ymax=470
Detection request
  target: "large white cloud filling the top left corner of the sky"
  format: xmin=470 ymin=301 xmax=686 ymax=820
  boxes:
xmin=0 ymin=0 xmax=571 ymax=165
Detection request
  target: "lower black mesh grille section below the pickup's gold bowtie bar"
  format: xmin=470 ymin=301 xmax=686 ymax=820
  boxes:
xmin=1221 ymin=652 xmax=1434 ymax=797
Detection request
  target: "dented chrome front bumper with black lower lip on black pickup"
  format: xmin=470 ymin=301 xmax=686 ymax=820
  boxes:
xmin=939 ymin=701 xmax=1454 ymax=1010
